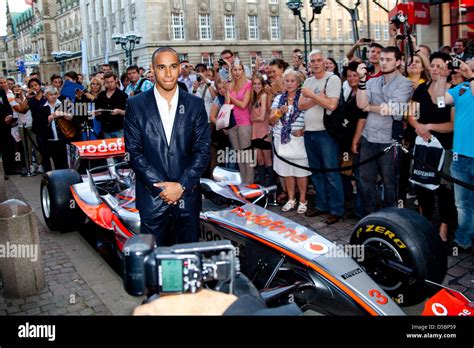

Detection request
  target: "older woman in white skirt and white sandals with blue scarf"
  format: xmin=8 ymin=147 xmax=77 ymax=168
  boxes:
xmin=270 ymin=70 xmax=311 ymax=214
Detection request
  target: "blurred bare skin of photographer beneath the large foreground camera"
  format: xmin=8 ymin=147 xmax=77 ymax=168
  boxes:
xmin=133 ymin=289 xmax=237 ymax=315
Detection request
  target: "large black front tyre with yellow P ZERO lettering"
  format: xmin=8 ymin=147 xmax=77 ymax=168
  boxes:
xmin=350 ymin=208 xmax=447 ymax=306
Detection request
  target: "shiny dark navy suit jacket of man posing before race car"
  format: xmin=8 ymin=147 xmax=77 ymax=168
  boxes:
xmin=124 ymin=88 xmax=210 ymax=218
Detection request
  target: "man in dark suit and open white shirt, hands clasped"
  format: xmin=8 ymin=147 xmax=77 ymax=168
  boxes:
xmin=124 ymin=47 xmax=210 ymax=245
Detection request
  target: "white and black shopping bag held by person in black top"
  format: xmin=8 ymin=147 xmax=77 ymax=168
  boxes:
xmin=410 ymin=136 xmax=445 ymax=190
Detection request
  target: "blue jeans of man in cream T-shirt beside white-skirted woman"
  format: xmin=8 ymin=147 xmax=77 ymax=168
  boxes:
xmin=304 ymin=131 xmax=344 ymax=216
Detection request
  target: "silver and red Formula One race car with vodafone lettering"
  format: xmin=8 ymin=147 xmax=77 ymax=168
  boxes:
xmin=41 ymin=139 xmax=470 ymax=315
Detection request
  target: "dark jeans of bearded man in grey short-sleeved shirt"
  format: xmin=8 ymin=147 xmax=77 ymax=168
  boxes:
xmin=360 ymin=137 xmax=399 ymax=214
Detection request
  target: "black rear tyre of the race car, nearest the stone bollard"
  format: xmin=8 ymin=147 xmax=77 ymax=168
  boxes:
xmin=41 ymin=169 xmax=85 ymax=232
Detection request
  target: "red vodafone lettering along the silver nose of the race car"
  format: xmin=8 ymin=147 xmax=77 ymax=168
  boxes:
xmin=230 ymin=207 xmax=308 ymax=243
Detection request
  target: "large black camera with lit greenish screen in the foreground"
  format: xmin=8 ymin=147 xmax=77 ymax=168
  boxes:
xmin=123 ymin=234 xmax=240 ymax=296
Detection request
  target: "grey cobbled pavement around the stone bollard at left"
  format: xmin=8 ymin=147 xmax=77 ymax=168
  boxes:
xmin=0 ymin=176 xmax=142 ymax=315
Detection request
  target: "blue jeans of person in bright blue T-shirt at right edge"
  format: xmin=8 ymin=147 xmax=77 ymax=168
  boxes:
xmin=451 ymin=155 xmax=474 ymax=248
